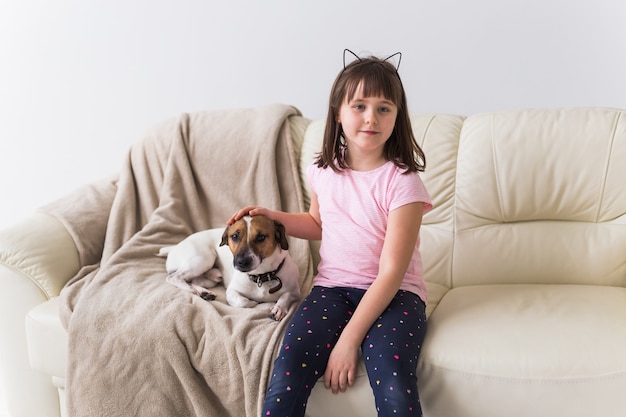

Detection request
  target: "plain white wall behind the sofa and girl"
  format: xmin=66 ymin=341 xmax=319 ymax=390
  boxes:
xmin=0 ymin=0 xmax=626 ymax=227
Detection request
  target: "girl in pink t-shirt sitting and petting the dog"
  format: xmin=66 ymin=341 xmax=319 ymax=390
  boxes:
xmin=228 ymin=51 xmax=431 ymax=417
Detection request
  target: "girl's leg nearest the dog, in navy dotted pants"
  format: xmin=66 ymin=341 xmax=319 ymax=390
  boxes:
xmin=262 ymin=287 xmax=354 ymax=417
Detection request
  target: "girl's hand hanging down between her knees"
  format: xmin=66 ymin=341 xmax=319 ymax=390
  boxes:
xmin=324 ymin=339 xmax=359 ymax=394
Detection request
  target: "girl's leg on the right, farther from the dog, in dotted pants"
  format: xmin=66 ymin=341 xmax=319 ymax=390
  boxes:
xmin=361 ymin=291 xmax=426 ymax=416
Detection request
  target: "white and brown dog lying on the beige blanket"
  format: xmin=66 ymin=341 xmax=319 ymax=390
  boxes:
xmin=158 ymin=216 xmax=300 ymax=321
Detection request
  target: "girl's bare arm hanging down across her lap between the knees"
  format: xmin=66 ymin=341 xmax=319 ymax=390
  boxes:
xmin=324 ymin=203 xmax=424 ymax=393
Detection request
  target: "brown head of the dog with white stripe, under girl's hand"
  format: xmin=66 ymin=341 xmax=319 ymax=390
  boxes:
xmin=220 ymin=216 xmax=289 ymax=273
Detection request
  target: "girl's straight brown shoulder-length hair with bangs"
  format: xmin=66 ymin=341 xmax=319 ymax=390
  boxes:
xmin=315 ymin=56 xmax=426 ymax=173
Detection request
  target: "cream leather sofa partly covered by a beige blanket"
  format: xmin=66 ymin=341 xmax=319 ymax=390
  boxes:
xmin=0 ymin=108 xmax=626 ymax=417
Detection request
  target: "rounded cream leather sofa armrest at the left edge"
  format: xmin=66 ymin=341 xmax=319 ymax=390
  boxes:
xmin=0 ymin=213 xmax=80 ymax=417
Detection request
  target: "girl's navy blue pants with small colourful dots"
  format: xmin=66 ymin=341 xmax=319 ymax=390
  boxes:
xmin=262 ymin=287 xmax=426 ymax=417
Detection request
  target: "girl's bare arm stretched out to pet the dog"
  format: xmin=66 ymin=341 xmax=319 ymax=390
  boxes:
xmin=226 ymin=192 xmax=322 ymax=240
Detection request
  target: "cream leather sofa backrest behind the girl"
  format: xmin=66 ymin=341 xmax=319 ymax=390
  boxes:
xmin=300 ymin=108 xmax=626 ymax=304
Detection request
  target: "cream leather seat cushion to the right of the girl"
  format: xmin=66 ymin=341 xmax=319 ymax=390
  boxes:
xmin=418 ymin=285 xmax=626 ymax=417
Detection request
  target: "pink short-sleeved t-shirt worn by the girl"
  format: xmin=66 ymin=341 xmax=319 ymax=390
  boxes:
xmin=307 ymin=162 xmax=432 ymax=302
